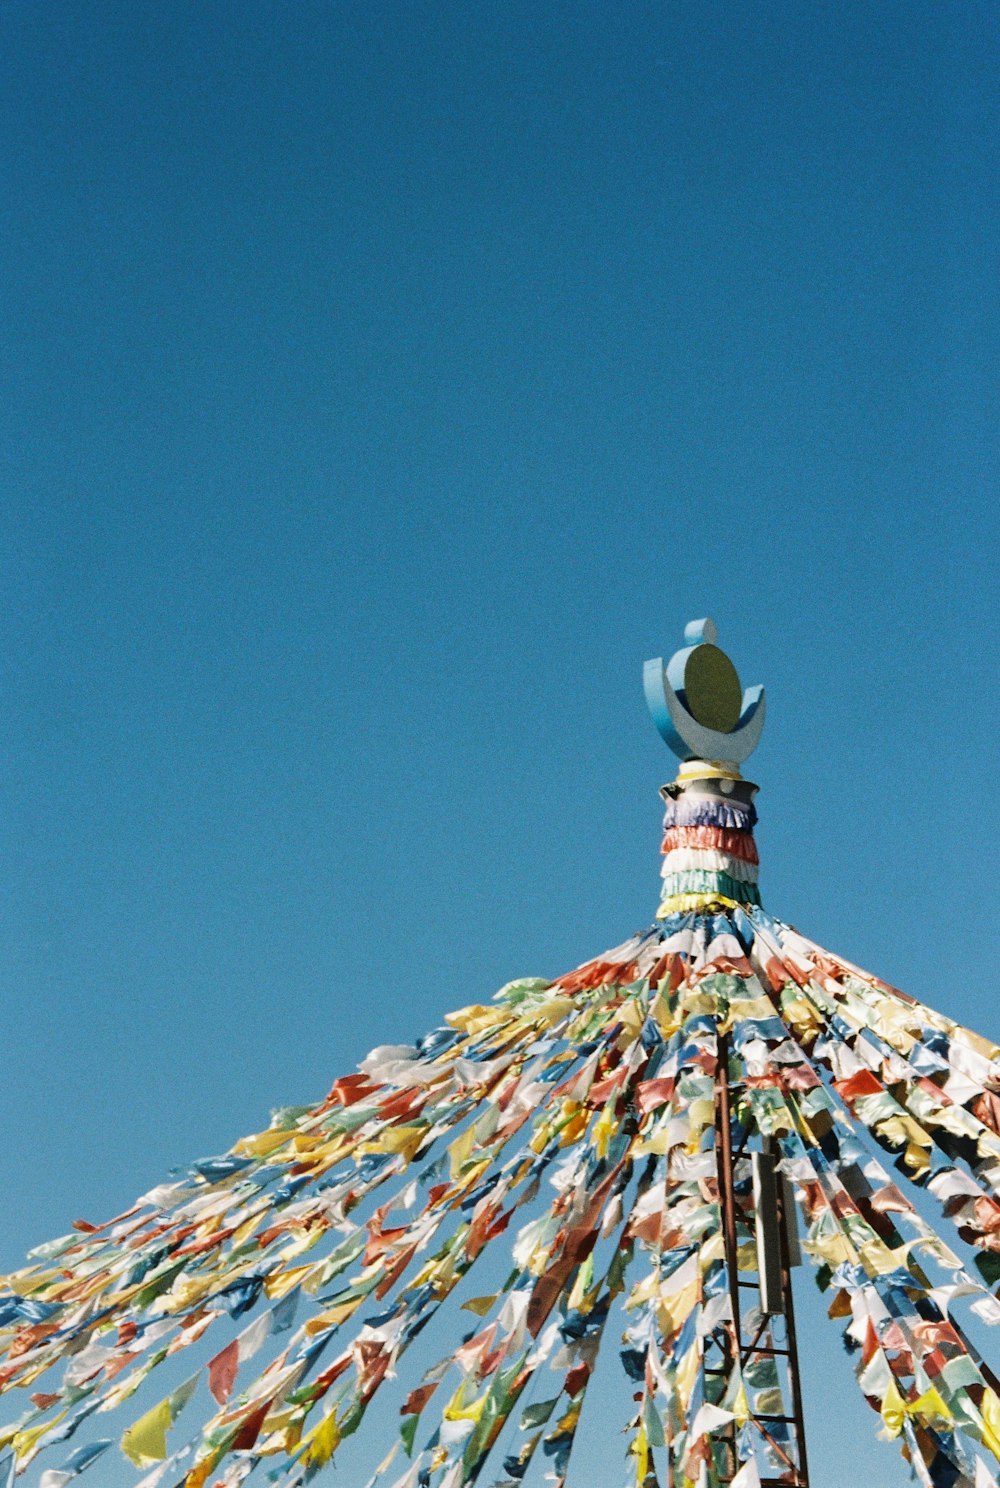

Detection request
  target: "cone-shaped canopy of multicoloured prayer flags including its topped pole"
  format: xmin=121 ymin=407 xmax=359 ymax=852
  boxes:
xmin=0 ymin=622 xmax=1000 ymax=1488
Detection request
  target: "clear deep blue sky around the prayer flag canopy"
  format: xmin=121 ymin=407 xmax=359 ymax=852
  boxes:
xmin=0 ymin=0 xmax=1000 ymax=1488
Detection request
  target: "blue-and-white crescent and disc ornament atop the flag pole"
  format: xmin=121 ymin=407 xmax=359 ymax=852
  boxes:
xmin=643 ymin=618 xmax=763 ymax=768
